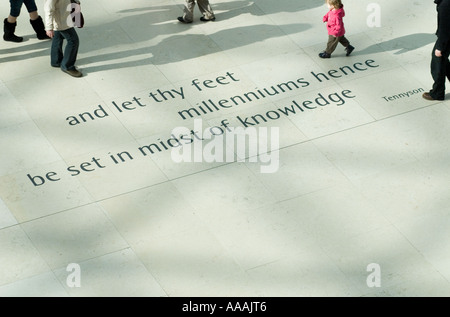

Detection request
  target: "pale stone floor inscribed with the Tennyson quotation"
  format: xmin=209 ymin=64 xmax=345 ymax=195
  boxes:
xmin=0 ymin=0 xmax=450 ymax=297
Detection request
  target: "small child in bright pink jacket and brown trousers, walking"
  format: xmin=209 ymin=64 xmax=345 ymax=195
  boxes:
xmin=319 ymin=0 xmax=355 ymax=58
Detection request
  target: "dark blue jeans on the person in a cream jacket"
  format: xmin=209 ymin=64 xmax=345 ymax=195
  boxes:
xmin=50 ymin=28 xmax=80 ymax=70
